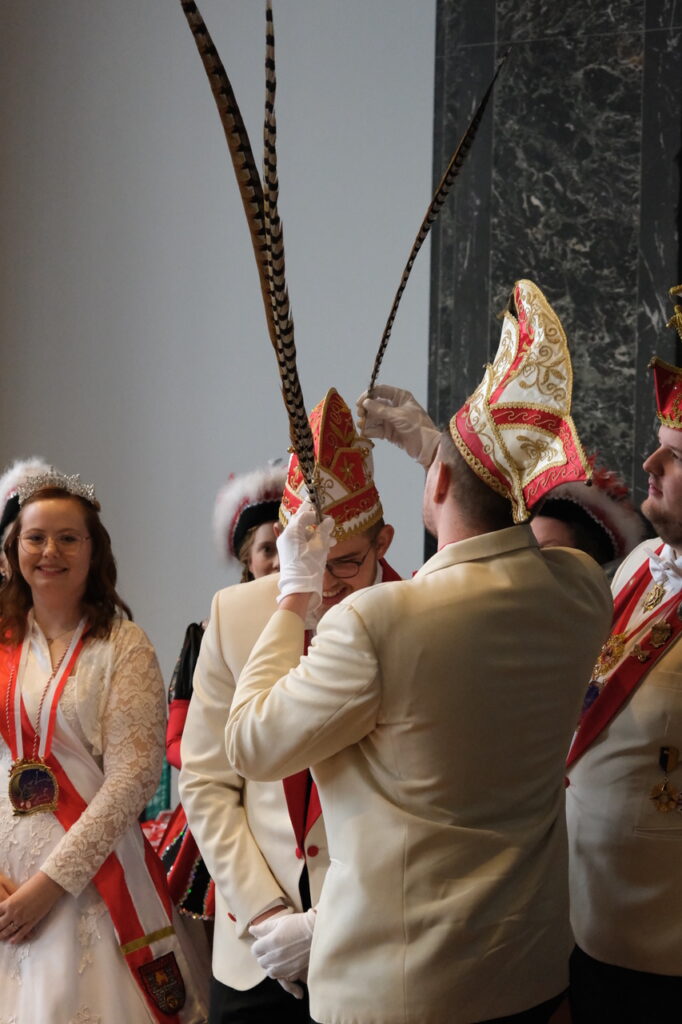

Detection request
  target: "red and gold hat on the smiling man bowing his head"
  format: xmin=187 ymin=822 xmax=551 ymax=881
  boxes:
xmin=280 ymin=388 xmax=383 ymax=541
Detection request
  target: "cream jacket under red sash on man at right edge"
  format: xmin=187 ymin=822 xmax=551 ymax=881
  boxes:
xmin=566 ymin=539 xmax=682 ymax=975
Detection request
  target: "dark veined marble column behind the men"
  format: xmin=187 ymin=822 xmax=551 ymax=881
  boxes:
xmin=429 ymin=0 xmax=682 ymax=512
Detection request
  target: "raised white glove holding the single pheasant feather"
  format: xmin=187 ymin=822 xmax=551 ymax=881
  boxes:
xmin=356 ymin=384 xmax=440 ymax=469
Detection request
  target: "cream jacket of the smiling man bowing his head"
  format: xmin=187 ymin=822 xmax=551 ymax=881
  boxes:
xmin=179 ymin=575 xmax=329 ymax=990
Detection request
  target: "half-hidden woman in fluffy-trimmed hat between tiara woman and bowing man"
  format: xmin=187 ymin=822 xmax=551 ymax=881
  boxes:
xmin=159 ymin=463 xmax=287 ymax=922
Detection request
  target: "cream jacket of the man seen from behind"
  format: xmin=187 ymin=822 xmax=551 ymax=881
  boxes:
xmin=226 ymin=526 xmax=612 ymax=1024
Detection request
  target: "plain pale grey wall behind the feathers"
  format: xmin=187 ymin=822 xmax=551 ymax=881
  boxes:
xmin=0 ymin=0 xmax=435 ymax=676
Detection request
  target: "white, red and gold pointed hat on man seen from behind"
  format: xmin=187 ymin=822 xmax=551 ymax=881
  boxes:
xmin=450 ymin=281 xmax=591 ymax=522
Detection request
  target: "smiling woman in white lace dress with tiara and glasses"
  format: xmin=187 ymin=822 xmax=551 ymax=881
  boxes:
xmin=0 ymin=474 xmax=206 ymax=1024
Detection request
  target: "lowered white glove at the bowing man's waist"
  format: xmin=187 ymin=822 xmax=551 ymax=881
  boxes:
xmin=249 ymin=908 xmax=317 ymax=995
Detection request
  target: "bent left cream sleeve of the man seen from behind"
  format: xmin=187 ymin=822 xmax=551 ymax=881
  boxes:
xmin=225 ymin=605 xmax=381 ymax=779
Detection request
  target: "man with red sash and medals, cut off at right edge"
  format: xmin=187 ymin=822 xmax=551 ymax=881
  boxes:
xmin=566 ymin=342 xmax=682 ymax=1024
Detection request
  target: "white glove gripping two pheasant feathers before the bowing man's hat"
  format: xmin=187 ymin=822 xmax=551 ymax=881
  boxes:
xmin=278 ymin=501 xmax=336 ymax=615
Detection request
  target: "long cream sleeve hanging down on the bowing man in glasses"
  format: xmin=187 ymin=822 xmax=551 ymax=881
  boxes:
xmin=179 ymin=594 xmax=289 ymax=936
